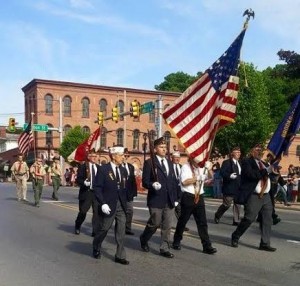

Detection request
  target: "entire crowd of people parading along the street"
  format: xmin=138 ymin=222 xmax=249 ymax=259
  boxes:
xmin=11 ymin=140 xmax=299 ymax=265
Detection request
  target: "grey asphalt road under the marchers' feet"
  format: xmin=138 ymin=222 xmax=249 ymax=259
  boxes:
xmin=0 ymin=183 xmax=300 ymax=286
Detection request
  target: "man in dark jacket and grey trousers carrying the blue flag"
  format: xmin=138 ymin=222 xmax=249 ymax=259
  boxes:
xmin=231 ymin=144 xmax=276 ymax=251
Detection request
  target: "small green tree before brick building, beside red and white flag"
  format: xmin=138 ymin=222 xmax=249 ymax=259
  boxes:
xmin=59 ymin=125 xmax=89 ymax=160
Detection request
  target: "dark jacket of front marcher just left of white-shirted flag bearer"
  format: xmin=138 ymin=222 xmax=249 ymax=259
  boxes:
xmin=142 ymin=156 xmax=179 ymax=209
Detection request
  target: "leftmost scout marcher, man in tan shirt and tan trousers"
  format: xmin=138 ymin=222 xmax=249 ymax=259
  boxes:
xmin=10 ymin=154 xmax=29 ymax=201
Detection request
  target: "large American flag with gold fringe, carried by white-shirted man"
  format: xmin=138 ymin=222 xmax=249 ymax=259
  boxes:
xmin=162 ymin=29 xmax=246 ymax=166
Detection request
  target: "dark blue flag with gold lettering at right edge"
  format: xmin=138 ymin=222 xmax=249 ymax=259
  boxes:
xmin=267 ymin=94 xmax=300 ymax=158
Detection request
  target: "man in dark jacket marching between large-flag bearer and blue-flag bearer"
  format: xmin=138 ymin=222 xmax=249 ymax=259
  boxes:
xmin=214 ymin=147 xmax=241 ymax=225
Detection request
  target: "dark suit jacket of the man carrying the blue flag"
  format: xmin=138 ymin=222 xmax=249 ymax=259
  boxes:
xmin=236 ymin=157 xmax=268 ymax=205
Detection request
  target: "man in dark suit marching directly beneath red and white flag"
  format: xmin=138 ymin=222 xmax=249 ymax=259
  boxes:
xmin=75 ymin=149 xmax=99 ymax=235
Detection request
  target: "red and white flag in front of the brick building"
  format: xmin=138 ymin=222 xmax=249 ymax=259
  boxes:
xmin=68 ymin=127 xmax=100 ymax=162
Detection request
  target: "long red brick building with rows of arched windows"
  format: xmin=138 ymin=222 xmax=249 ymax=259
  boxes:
xmin=22 ymin=79 xmax=180 ymax=167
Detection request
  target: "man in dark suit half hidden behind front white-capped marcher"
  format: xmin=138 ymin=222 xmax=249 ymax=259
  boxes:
xmin=122 ymin=148 xmax=137 ymax=235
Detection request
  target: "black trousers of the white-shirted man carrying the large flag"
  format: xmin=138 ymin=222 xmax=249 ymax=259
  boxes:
xmin=173 ymin=192 xmax=211 ymax=248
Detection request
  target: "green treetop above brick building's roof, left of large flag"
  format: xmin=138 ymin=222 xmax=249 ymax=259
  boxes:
xmin=154 ymin=72 xmax=202 ymax=92
